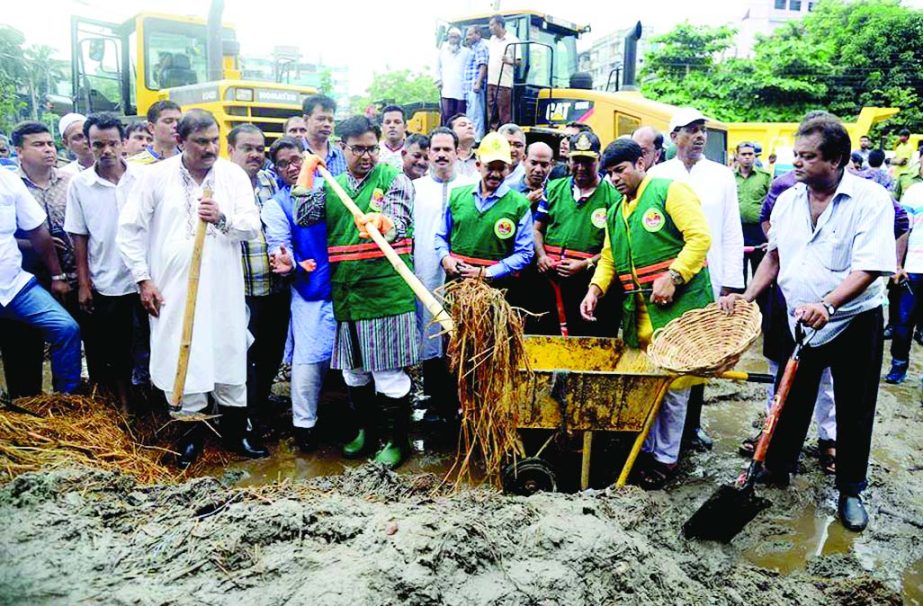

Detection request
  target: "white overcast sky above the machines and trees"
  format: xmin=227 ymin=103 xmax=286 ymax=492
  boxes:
xmin=0 ymin=0 xmax=923 ymax=94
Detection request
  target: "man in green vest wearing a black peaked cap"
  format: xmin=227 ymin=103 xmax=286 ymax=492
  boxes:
xmin=533 ymin=132 xmax=621 ymax=337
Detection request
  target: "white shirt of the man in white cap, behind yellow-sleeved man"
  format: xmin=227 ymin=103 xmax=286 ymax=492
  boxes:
xmin=648 ymin=158 xmax=744 ymax=299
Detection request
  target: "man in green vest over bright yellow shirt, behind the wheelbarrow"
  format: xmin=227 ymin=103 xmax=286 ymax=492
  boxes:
xmin=580 ymin=139 xmax=713 ymax=489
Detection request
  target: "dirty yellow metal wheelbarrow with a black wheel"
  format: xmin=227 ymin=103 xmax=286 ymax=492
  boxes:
xmin=503 ymin=336 xmax=773 ymax=494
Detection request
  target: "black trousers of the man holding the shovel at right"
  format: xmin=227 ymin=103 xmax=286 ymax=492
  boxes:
xmin=766 ymin=307 xmax=884 ymax=495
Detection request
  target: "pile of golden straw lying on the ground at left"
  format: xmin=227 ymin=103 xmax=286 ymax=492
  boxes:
xmin=0 ymin=394 xmax=226 ymax=484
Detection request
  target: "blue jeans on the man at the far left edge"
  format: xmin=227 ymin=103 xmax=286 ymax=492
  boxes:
xmin=0 ymin=278 xmax=80 ymax=393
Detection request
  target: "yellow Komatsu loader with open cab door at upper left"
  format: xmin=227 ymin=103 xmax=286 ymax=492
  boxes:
xmin=71 ymin=0 xmax=315 ymax=148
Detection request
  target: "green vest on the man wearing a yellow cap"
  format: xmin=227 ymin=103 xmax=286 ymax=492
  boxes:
xmin=449 ymin=183 xmax=531 ymax=267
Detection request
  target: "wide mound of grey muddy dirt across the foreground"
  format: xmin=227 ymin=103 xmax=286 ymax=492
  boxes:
xmin=0 ymin=465 xmax=900 ymax=605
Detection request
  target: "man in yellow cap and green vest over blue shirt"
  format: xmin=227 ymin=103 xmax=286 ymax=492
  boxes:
xmin=436 ymin=133 xmax=533 ymax=292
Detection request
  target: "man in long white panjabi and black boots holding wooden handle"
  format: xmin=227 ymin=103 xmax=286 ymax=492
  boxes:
xmin=116 ymin=110 xmax=268 ymax=467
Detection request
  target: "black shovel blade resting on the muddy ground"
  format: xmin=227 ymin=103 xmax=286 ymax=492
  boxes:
xmin=683 ymin=485 xmax=770 ymax=543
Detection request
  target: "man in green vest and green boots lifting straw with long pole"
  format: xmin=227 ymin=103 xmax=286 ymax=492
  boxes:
xmin=292 ymin=116 xmax=419 ymax=467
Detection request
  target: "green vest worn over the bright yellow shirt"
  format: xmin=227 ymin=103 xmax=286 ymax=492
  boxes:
xmin=608 ymin=178 xmax=714 ymax=347
